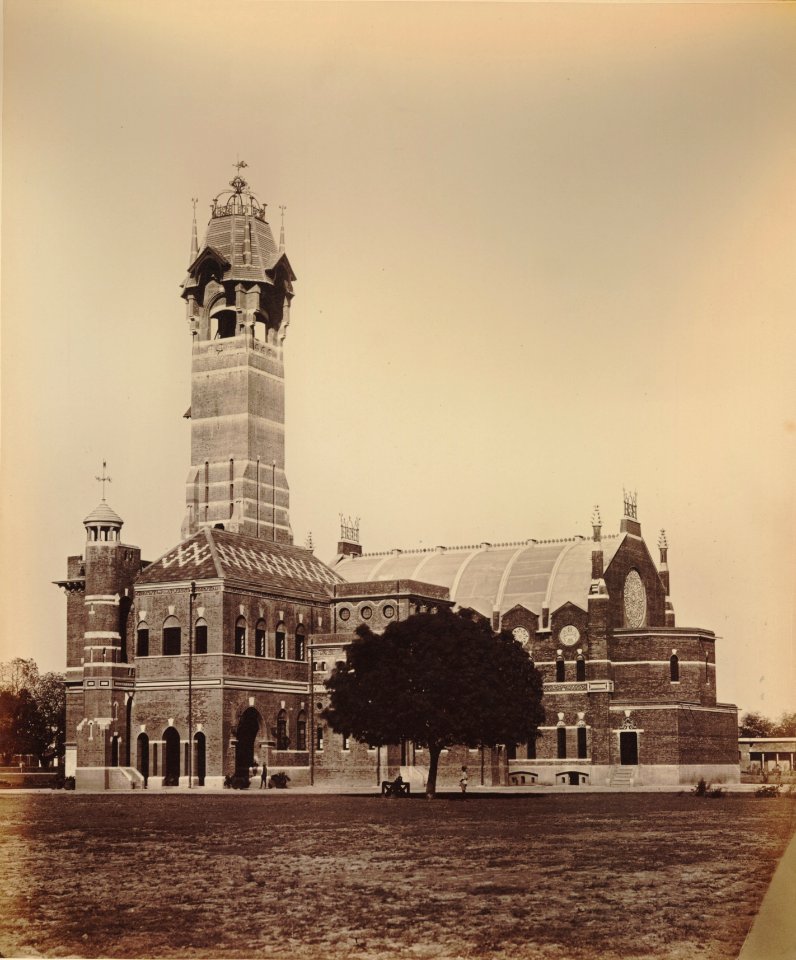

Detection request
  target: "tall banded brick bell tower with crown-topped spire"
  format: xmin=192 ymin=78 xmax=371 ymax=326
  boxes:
xmin=182 ymin=162 xmax=296 ymax=543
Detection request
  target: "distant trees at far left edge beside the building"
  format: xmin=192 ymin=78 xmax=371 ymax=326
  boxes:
xmin=0 ymin=657 xmax=66 ymax=766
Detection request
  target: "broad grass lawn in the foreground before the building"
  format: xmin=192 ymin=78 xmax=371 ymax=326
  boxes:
xmin=0 ymin=790 xmax=796 ymax=960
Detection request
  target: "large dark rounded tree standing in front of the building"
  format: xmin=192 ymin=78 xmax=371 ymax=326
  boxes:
xmin=322 ymin=609 xmax=544 ymax=796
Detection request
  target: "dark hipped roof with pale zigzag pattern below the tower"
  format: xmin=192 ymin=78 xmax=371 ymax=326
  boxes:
xmin=136 ymin=527 xmax=343 ymax=603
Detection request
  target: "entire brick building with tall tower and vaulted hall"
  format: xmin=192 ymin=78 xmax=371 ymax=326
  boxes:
xmin=58 ymin=171 xmax=738 ymax=788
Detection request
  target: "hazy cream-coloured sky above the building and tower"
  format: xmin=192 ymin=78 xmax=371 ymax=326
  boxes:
xmin=0 ymin=0 xmax=796 ymax=715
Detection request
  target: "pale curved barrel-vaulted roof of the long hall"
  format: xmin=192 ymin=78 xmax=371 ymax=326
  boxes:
xmin=333 ymin=534 xmax=624 ymax=616
